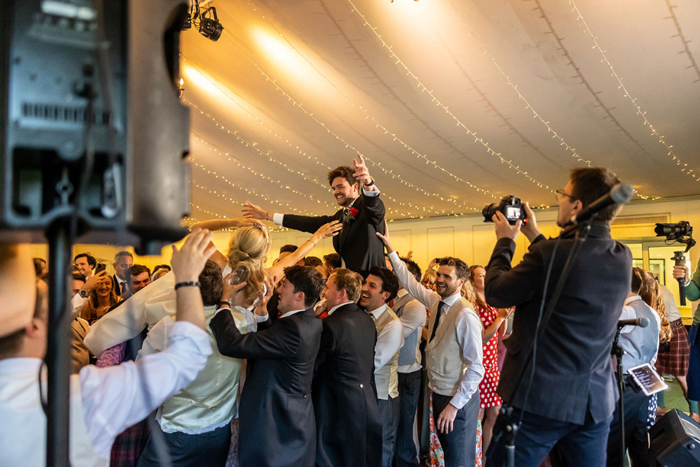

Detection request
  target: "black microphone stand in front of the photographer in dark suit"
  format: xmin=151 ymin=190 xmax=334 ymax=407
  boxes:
xmin=486 ymin=220 xmax=595 ymax=467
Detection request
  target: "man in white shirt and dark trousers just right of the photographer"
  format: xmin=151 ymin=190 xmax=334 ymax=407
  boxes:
xmin=607 ymin=268 xmax=661 ymax=467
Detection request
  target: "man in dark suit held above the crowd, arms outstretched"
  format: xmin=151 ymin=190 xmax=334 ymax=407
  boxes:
xmin=243 ymin=153 xmax=386 ymax=272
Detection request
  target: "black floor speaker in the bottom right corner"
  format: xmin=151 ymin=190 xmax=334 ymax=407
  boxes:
xmin=649 ymin=409 xmax=700 ymax=467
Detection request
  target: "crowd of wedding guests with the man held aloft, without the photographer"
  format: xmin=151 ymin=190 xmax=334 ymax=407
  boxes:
xmin=0 ymin=158 xmax=700 ymax=467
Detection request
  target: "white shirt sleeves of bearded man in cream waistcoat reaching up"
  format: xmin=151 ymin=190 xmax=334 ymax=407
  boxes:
xmin=389 ymin=251 xmax=485 ymax=409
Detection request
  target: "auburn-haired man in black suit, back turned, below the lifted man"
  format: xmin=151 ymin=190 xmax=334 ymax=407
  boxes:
xmin=313 ymin=269 xmax=382 ymax=467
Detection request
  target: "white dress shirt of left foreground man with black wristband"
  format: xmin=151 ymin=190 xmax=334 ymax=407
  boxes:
xmin=0 ymin=322 xmax=212 ymax=466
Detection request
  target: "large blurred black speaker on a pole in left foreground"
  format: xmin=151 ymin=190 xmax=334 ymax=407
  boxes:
xmin=0 ymin=0 xmax=189 ymax=249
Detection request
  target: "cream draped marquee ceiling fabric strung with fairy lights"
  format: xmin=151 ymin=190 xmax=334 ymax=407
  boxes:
xmin=181 ymin=0 xmax=700 ymax=220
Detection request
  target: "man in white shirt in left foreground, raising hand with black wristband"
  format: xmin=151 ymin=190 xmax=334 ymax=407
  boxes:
xmin=0 ymin=231 xmax=215 ymax=466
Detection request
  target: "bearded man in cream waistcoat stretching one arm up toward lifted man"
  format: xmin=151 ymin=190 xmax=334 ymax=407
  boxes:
xmin=378 ymin=232 xmax=484 ymax=467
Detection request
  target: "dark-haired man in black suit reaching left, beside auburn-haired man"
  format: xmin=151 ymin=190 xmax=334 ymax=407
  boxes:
xmin=210 ymin=266 xmax=323 ymax=467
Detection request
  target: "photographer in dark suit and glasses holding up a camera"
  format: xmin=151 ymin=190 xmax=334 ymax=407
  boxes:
xmin=486 ymin=167 xmax=632 ymax=467
